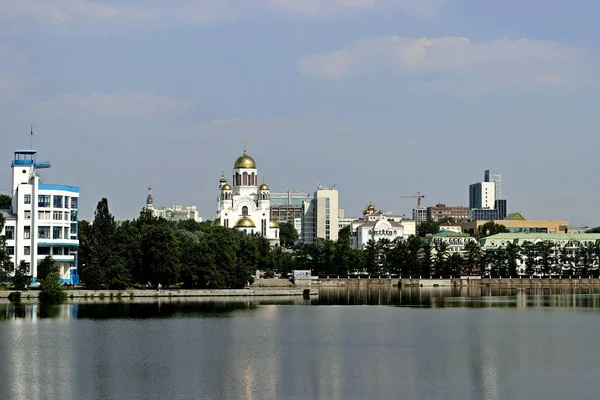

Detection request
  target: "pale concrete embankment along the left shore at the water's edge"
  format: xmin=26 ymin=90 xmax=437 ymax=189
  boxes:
xmin=0 ymin=288 xmax=319 ymax=299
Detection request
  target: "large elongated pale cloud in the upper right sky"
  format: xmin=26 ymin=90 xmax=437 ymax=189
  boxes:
xmin=299 ymin=36 xmax=589 ymax=84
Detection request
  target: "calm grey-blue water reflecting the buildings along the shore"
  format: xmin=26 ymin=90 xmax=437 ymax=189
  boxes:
xmin=0 ymin=288 xmax=600 ymax=400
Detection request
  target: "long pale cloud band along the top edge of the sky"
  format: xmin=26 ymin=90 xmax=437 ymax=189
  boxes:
xmin=0 ymin=0 xmax=445 ymax=25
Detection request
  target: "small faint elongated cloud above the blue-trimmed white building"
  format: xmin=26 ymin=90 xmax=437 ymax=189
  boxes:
xmin=39 ymin=93 xmax=192 ymax=117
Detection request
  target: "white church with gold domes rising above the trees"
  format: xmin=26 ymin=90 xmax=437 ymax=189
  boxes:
xmin=213 ymin=145 xmax=279 ymax=247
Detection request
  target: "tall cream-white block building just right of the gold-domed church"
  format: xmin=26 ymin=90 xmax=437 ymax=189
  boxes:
xmin=301 ymin=184 xmax=339 ymax=243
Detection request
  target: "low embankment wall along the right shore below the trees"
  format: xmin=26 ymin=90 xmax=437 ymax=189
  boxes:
xmin=400 ymin=277 xmax=600 ymax=289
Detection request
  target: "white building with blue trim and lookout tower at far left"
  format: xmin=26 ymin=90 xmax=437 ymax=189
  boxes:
xmin=1 ymin=150 xmax=79 ymax=284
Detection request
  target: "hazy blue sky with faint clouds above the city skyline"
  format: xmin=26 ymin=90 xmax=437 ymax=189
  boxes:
xmin=0 ymin=0 xmax=600 ymax=226
